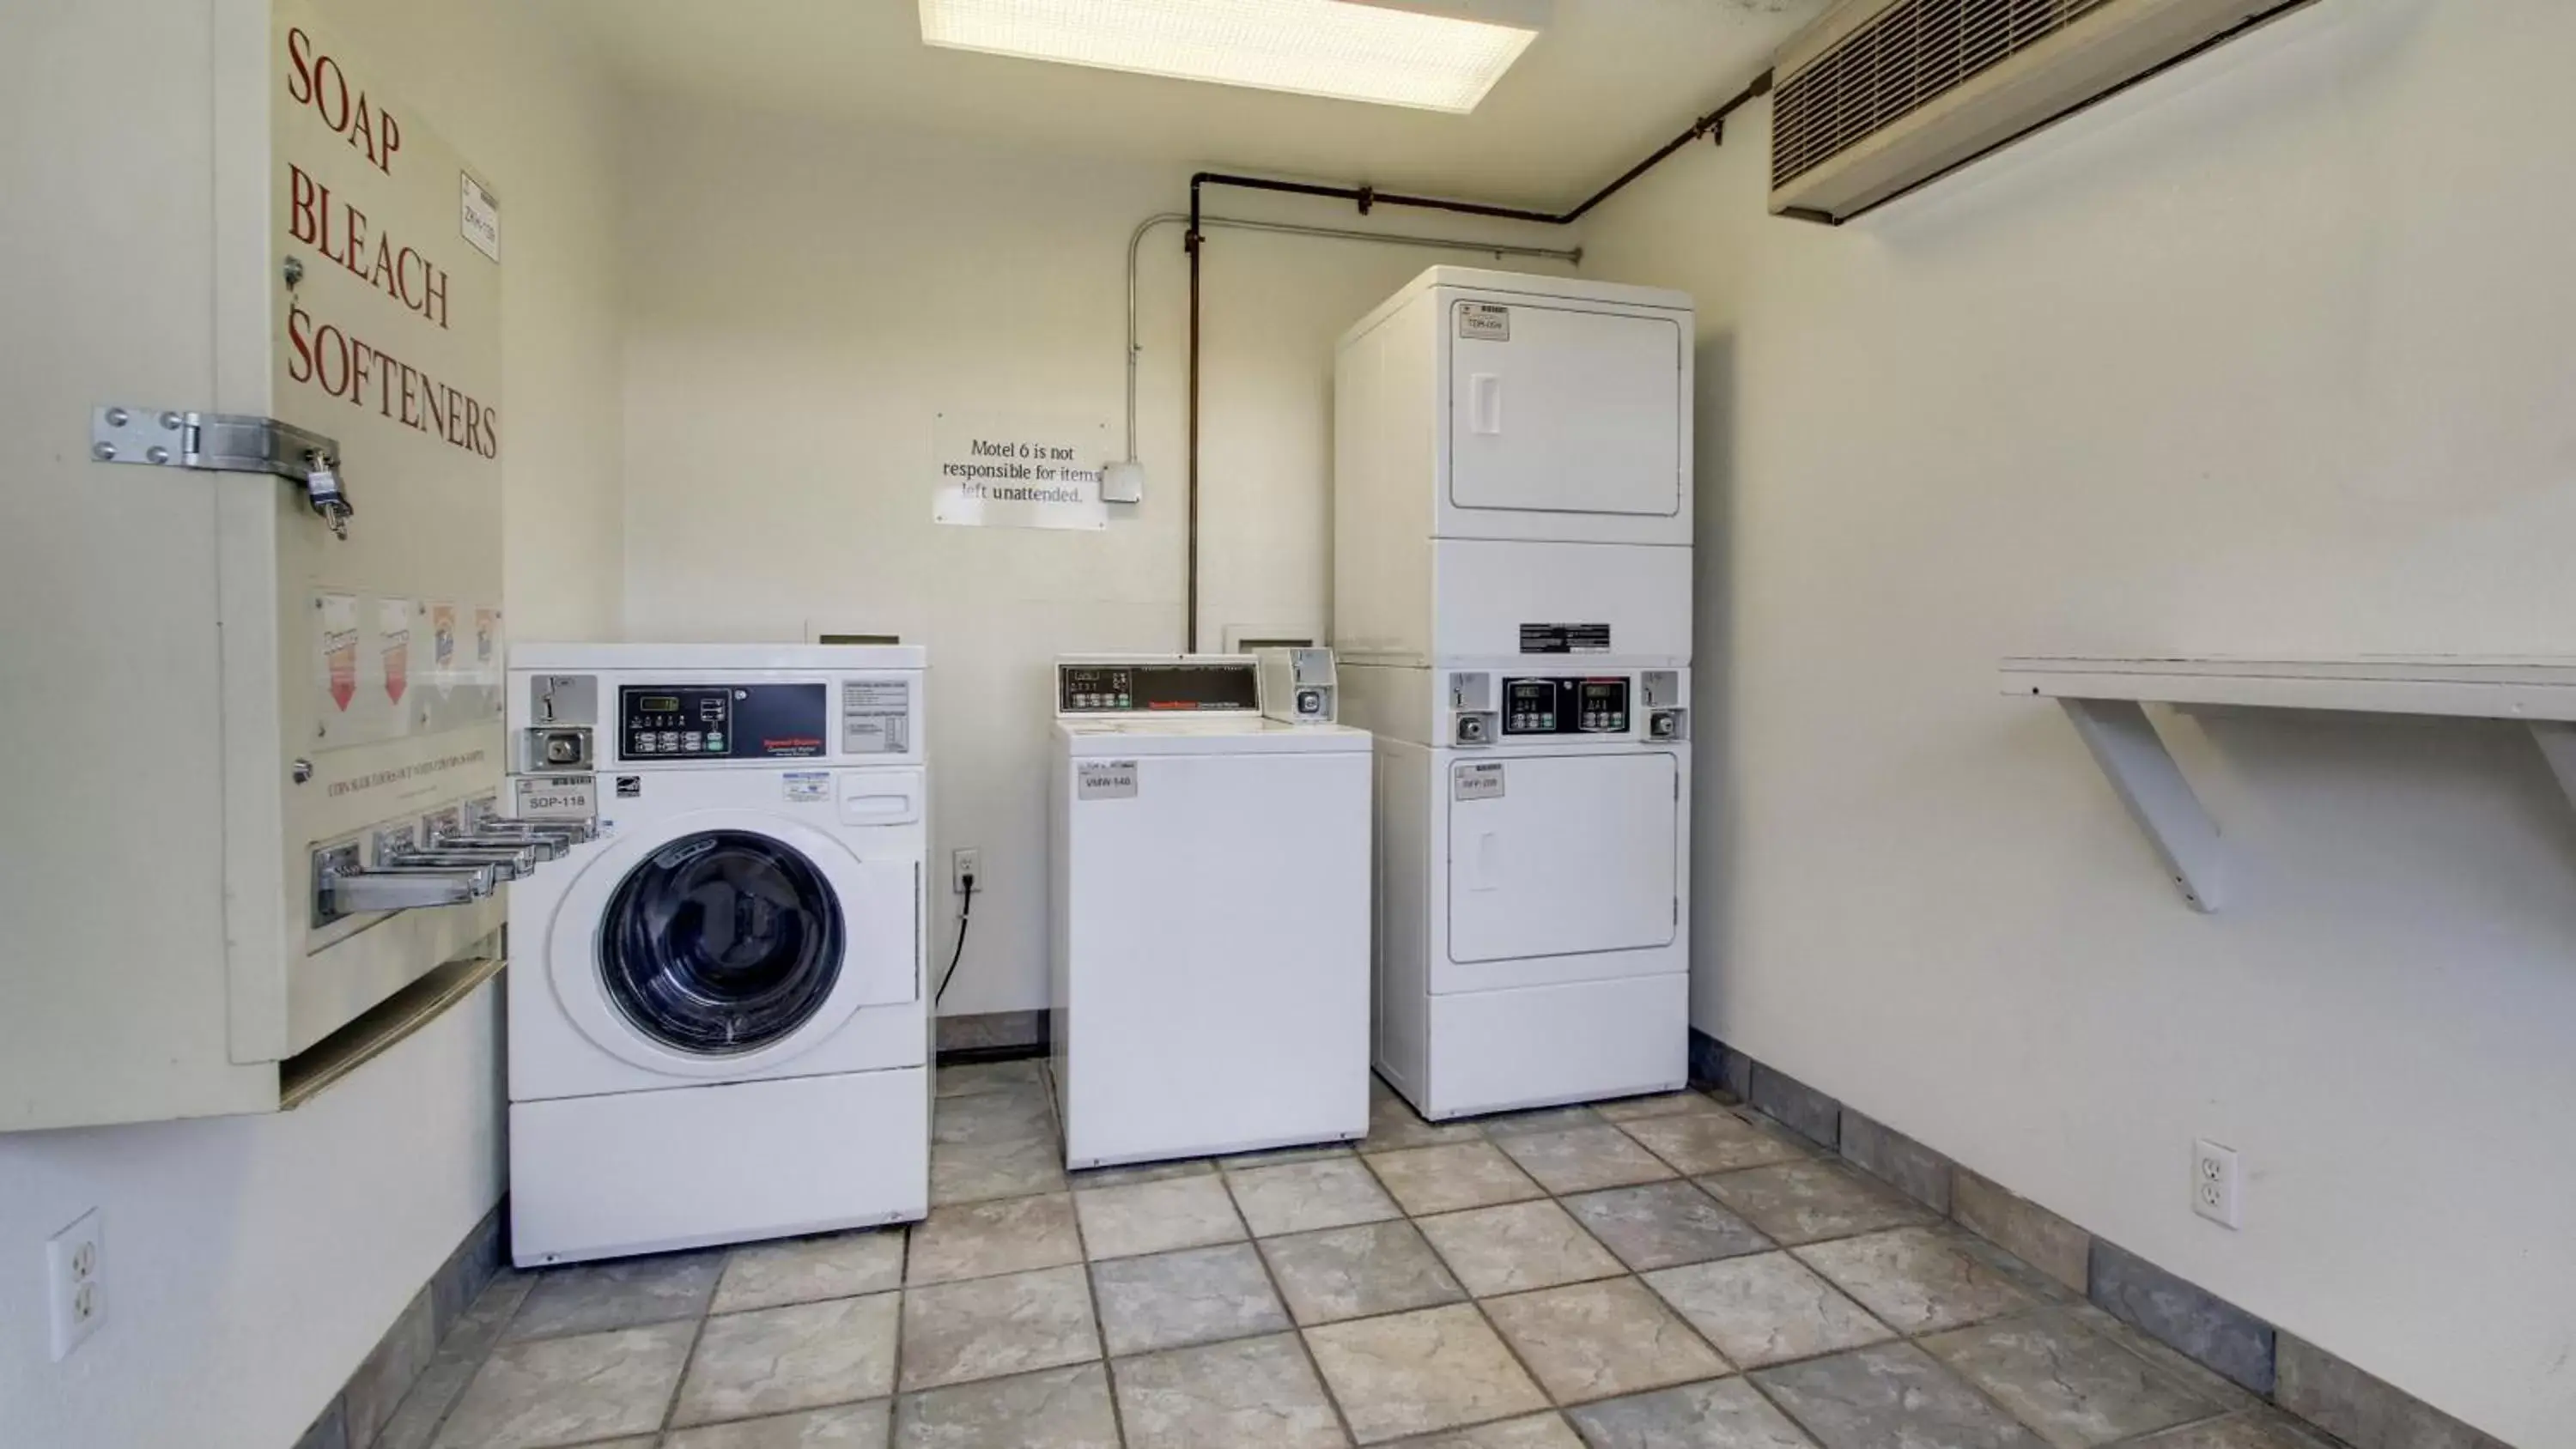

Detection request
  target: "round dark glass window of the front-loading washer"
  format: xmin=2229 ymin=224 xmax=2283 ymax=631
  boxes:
xmin=600 ymin=831 xmax=842 ymax=1055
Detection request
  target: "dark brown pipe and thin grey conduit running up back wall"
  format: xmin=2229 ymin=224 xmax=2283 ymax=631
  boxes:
xmin=1170 ymin=70 xmax=1772 ymax=654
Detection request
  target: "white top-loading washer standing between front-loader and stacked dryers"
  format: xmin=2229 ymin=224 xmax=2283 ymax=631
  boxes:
xmin=1048 ymin=654 xmax=1370 ymax=1168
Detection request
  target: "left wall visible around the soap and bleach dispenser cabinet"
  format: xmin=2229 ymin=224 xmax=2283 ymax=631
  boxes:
xmin=0 ymin=0 xmax=621 ymax=1449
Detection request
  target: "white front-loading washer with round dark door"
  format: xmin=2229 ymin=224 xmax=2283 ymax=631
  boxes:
xmin=507 ymin=644 xmax=930 ymax=1266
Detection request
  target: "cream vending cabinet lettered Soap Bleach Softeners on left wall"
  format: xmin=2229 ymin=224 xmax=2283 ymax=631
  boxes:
xmin=0 ymin=0 xmax=510 ymax=1130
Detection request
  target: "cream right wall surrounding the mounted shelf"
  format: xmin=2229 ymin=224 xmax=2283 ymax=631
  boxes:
xmin=1587 ymin=0 xmax=2576 ymax=1449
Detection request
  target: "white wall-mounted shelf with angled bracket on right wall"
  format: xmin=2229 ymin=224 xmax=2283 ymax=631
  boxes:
xmin=2004 ymin=657 xmax=2576 ymax=911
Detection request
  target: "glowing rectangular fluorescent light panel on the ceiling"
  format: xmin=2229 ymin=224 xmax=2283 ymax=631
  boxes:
xmin=922 ymin=0 xmax=1546 ymax=113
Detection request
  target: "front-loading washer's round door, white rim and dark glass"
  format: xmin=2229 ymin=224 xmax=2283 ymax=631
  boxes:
xmin=549 ymin=810 xmax=920 ymax=1078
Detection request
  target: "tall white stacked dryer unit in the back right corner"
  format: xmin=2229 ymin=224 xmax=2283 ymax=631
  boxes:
xmin=1334 ymin=268 xmax=1692 ymax=1117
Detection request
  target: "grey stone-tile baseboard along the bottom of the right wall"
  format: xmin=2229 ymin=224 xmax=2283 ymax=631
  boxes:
xmin=1690 ymin=1029 xmax=2512 ymax=1449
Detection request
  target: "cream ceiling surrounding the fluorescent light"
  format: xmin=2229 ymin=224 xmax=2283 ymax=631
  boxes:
xmin=541 ymin=0 xmax=1826 ymax=206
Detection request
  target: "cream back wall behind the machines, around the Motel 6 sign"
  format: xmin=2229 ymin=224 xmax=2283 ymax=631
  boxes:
xmin=626 ymin=103 xmax=1571 ymax=1014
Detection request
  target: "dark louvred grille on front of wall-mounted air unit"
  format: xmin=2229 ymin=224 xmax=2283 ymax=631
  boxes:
xmin=1772 ymin=0 xmax=2112 ymax=185
